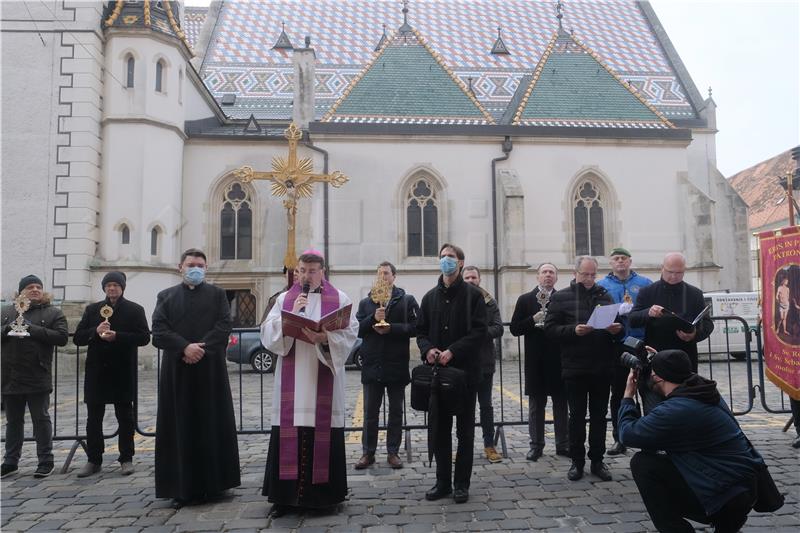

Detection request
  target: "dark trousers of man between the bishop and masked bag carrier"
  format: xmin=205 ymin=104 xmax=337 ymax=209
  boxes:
xmin=361 ymin=383 xmax=406 ymax=455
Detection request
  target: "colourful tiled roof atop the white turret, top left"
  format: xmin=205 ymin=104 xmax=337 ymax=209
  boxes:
xmin=102 ymin=0 xmax=192 ymax=54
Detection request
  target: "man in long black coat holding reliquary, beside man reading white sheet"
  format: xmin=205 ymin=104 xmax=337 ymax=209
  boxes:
xmin=511 ymin=263 xmax=569 ymax=461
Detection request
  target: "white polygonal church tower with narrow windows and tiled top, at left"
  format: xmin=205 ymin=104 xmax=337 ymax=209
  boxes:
xmin=99 ymin=0 xmax=192 ymax=296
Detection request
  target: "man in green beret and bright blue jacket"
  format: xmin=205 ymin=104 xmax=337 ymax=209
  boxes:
xmin=597 ymin=246 xmax=653 ymax=455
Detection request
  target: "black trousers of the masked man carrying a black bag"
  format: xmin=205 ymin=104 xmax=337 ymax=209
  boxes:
xmin=434 ymin=385 xmax=477 ymax=489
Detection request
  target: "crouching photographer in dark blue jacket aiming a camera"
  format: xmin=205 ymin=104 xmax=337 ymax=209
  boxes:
xmin=619 ymin=350 xmax=764 ymax=533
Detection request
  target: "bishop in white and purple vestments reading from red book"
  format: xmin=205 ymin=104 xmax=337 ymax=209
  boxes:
xmin=261 ymin=250 xmax=358 ymax=516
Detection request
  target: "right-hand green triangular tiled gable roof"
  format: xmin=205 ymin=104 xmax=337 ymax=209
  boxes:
xmin=512 ymin=29 xmax=674 ymax=128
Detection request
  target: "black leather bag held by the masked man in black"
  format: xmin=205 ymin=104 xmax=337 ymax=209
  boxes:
xmin=411 ymin=363 xmax=467 ymax=416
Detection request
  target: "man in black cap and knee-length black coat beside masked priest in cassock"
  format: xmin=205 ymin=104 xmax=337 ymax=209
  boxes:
xmin=74 ymin=272 xmax=150 ymax=477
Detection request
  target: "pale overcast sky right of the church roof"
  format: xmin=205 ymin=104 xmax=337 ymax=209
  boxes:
xmin=185 ymin=0 xmax=800 ymax=177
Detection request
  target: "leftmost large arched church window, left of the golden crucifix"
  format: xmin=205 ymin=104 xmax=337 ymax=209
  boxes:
xmin=219 ymin=182 xmax=253 ymax=259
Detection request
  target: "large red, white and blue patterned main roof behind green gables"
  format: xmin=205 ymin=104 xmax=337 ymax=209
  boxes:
xmin=201 ymin=0 xmax=697 ymax=120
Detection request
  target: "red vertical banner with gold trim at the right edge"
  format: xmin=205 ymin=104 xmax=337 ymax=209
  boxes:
xmin=758 ymin=227 xmax=800 ymax=400
